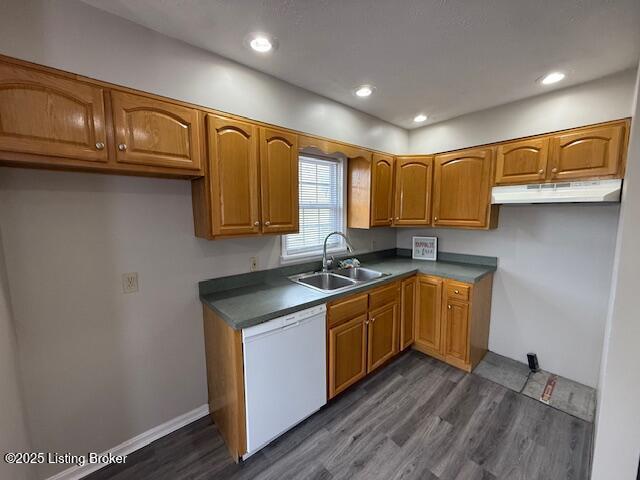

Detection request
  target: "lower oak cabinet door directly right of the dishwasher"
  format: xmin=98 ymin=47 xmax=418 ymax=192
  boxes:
xmin=329 ymin=315 xmax=367 ymax=398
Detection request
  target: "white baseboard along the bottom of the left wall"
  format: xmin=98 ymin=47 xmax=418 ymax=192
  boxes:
xmin=47 ymin=405 xmax=209 ymax=480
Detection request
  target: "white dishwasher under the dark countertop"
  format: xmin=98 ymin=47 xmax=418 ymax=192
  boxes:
xmin=242 ymin=305 xmax=327 ymax=458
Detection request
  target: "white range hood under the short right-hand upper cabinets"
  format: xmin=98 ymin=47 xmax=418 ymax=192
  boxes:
xmin=491 ymin=179 xmax=622 ymax=204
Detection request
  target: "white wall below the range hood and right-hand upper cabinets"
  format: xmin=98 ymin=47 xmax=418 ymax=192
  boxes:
xmin=397 ymin=205 xmax=619 ymax=386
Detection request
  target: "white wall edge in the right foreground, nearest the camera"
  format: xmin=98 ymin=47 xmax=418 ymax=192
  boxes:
xmin=591 ymin=66 xmax=640 ymax=480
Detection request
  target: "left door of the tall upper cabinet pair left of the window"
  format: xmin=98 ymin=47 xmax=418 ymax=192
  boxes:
xmin=207 ymin=115 xmax=260 ymax=236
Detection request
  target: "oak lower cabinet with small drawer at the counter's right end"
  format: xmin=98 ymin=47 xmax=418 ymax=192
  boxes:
xmin=413 ymin=274 xmax=493 ymax=372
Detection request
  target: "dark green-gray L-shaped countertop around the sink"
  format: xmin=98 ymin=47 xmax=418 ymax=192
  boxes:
xmin=200 ymin=251 xmax=497 ymax=330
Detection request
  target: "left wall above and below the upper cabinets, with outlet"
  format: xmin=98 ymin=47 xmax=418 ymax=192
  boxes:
xmin=0 ymin=0 xmax=400 ymax=478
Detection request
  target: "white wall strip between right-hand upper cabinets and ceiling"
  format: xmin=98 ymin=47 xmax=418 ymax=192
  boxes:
xmin=409 ymin=70 xmax=635 ymax=153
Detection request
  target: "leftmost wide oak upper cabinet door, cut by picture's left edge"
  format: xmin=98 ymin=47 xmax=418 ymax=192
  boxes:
xmin=0 ymin=63 xmax=108 ymax=165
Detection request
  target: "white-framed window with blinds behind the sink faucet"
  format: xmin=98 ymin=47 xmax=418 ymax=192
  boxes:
xmin=282 ymin=155 xmax=345 ymax=260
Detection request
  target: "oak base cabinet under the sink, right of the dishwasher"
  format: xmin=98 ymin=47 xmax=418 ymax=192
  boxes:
xmin=327 ymin=282 xmax=400 ymax=398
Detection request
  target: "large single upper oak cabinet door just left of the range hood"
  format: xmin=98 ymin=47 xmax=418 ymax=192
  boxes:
xmin=433 ymin=148 xmax=492 ymax=228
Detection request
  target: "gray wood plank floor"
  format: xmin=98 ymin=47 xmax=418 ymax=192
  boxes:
xmin=87 ymin=352 xmax=592 ymax=480
